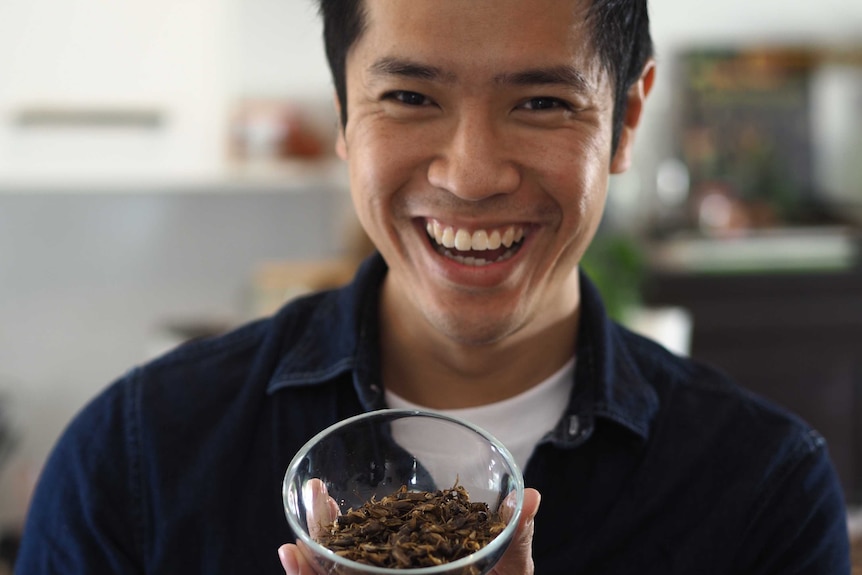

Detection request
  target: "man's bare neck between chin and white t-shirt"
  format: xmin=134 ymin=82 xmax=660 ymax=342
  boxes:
xmin=381 ymin=274 xmax=580 ymax=409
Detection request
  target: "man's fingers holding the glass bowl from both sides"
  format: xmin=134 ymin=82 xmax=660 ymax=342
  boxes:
xmin=278 ymin=486 xmax=541 ymax=575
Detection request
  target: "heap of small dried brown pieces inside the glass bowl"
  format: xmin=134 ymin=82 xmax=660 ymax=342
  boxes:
xmin=318 ymin=484 xmax=506 ymax=569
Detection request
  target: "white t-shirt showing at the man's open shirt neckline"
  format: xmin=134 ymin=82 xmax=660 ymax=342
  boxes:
xmin=385 ymin=358 xmax=575 ymax=470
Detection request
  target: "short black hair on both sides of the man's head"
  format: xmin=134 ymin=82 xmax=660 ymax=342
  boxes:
xmin=317 ymin=0 xmax=653 ymax=151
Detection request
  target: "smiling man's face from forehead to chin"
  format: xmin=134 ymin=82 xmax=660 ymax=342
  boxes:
xmin=338 ymin=0 xmax=640 ymax=345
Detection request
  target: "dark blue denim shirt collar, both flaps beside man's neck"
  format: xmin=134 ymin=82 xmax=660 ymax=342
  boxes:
xmin=267 ymin=254 xmax=658 ymax=445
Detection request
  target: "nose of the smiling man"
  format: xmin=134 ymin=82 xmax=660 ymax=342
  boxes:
xmin=428 ymin=113 xmax=521 ymax=201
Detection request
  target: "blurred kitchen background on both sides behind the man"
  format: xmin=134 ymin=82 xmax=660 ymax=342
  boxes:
xmin=0 ymin=0 xmax=862 ymax=568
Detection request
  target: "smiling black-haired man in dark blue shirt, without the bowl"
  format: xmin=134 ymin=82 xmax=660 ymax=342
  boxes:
xmin=21 ymin=0 xmax=849 ymax=575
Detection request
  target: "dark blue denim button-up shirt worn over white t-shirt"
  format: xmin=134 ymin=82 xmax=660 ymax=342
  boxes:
xmin=17 ymin=256 xmax=850 ymax=575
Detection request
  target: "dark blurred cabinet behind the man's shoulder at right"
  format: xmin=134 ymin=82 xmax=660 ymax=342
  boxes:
xmin=645 ymin=269 xmax=862 ymax=505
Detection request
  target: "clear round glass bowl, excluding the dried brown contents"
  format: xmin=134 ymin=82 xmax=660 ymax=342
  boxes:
xmin=282 ymin=409 xmax=524 ymax=575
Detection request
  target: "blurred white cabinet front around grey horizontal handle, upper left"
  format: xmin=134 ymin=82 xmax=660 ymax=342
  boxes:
xmin=0 ymin=0 xmax=232 ymax=181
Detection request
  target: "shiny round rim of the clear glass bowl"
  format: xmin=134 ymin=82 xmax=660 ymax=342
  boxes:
xmin=282 ymin=408 xmax=524 ymax=575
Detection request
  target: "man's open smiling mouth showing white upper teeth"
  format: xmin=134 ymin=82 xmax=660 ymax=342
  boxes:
xmin=425 ymin=220 xmax=525 ymax=267
